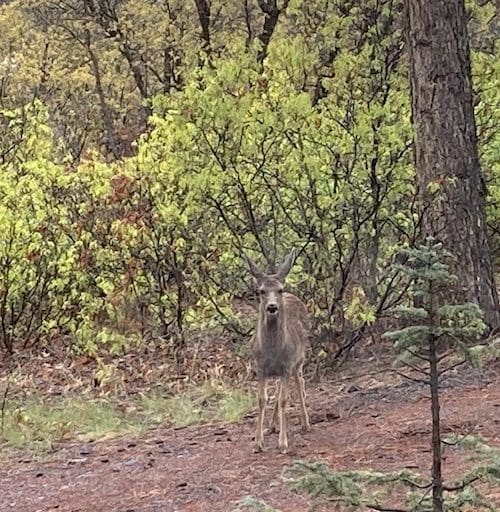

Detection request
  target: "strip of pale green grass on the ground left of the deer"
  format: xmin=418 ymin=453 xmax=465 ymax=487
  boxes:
xmin=0 ymin=380 xmax=254 ymax=453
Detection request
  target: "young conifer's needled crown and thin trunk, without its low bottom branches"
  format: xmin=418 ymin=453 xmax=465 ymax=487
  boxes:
xmin=385 ymin=239 xmax=486 ymax=512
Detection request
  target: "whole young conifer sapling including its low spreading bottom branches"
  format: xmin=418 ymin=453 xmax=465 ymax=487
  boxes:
xmin=288 ymin=239 xmax=500 ymax=512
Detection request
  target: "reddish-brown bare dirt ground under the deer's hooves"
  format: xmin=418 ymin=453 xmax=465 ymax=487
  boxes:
xmin=0 ymin=364 xmax=500 ymax=512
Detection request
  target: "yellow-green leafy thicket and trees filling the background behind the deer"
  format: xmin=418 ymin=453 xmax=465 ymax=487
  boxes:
xmin=0 ymin=0 xmax=500 ymax=355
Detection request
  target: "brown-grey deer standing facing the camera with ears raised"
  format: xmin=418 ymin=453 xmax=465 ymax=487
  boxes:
xmin=244 ymin=250 xmax=311 ymax=453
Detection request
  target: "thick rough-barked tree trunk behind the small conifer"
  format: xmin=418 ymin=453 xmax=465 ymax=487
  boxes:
xmin=405 ymin=0 xmax=500 ymax=328
